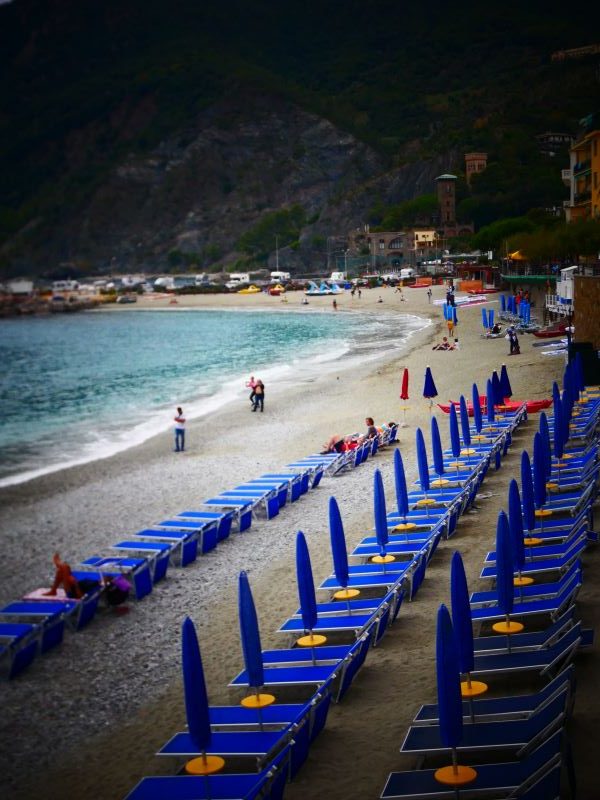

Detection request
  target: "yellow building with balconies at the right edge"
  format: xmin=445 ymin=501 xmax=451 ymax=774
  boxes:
xmin=565 ymin=114 xmax=600 ymax=222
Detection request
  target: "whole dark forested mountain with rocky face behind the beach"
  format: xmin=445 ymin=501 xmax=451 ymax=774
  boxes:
xmin=0 ymin=0 xmax=600 ymax=273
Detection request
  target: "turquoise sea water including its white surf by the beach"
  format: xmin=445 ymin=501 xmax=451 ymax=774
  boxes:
xmin=0 ymin=309 xmax=423 ymax=486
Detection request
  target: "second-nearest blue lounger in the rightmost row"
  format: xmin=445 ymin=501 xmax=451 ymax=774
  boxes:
xmin=400 ymin=687 xmax=569 ymax=758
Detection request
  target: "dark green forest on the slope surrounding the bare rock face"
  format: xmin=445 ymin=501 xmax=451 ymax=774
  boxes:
xmin=0 ymin=0 xmax=600 ymax=272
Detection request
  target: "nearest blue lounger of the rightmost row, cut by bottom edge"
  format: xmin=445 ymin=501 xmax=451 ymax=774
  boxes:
xmin=381 ymin=731 xmax=562 ymax=800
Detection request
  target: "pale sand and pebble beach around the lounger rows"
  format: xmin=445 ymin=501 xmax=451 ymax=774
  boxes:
xmin=0 ymin=287 xmax=600 ymax=800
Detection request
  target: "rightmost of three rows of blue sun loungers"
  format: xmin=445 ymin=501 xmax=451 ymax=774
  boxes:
xmin=381 ymin=376 xmax=600 ymax=800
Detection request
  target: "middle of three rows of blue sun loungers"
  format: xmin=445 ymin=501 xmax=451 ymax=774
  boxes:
xmin=123 ymin=378 xmax=523 ymax=800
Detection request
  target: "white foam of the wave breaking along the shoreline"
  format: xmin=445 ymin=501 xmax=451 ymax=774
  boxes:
xmin=0 ymin=309 xmax=431 ymax=488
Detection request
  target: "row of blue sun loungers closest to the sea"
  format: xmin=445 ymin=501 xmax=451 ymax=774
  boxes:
xmin=0 ymin=412 xmax=396 ymax=678
